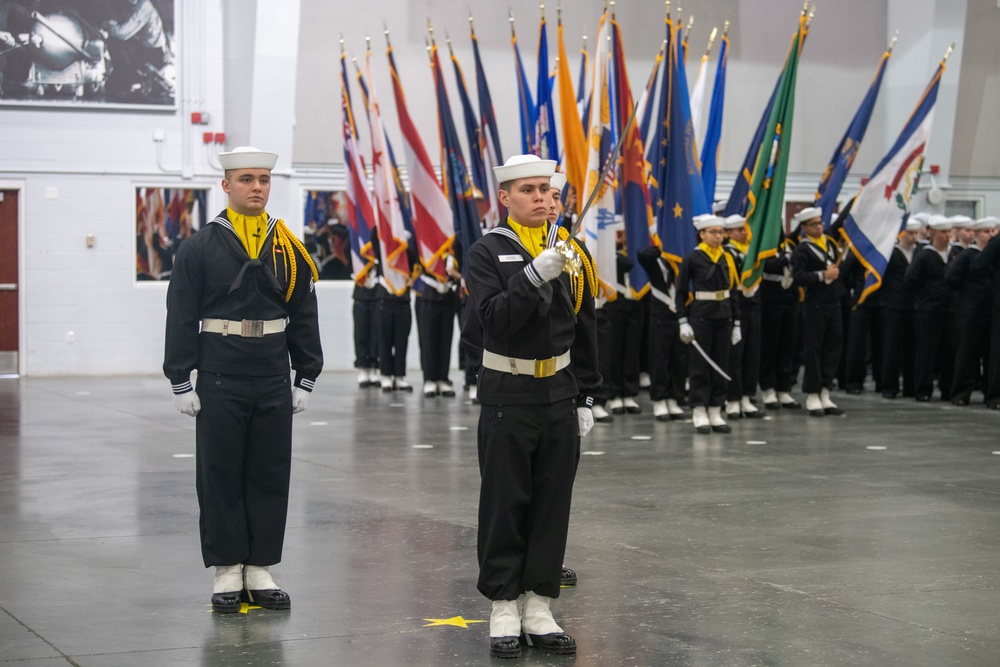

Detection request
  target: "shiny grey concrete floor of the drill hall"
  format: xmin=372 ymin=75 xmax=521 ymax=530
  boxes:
xmin=0 ymin=373 xmax=1000 ymax=667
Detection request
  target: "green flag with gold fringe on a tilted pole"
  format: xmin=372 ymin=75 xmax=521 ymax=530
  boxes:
xmin=740 ymin=15 xmax=808 ymax=289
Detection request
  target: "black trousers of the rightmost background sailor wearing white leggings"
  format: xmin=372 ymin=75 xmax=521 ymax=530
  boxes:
xmin=802 ymin=301 xmax=844 ymax=394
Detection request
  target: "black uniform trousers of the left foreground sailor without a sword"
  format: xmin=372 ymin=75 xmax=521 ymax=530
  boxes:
xmin=195 ymin=373 xmax=292 ymax=567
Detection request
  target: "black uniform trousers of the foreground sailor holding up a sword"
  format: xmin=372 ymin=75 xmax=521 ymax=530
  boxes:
xmin=477 ymin=398 xmax=580 ymax=600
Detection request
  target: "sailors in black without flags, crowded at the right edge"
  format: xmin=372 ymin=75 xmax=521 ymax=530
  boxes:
xmin=845 ymin=213 xmax=1000 ymax=409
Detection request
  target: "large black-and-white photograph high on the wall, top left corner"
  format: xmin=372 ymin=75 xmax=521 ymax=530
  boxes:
xmin=0 ymin=0 xmax=178 ymax=110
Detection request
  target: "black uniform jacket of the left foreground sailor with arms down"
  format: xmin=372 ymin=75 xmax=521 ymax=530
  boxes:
xmin=163 ymin=211 xmax=323 ymax=393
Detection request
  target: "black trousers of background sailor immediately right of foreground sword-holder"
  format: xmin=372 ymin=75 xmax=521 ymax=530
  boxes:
xmin=599 ymin=294 xmax=642 ymax=398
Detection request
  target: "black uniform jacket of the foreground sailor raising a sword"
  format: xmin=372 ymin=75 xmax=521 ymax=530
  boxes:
xmin=462 ymin=220 xmax=601 ymax=406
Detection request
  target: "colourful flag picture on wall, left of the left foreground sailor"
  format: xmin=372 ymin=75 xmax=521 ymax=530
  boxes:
xmin=135 ymin=186 xmax=209 ymax=282
